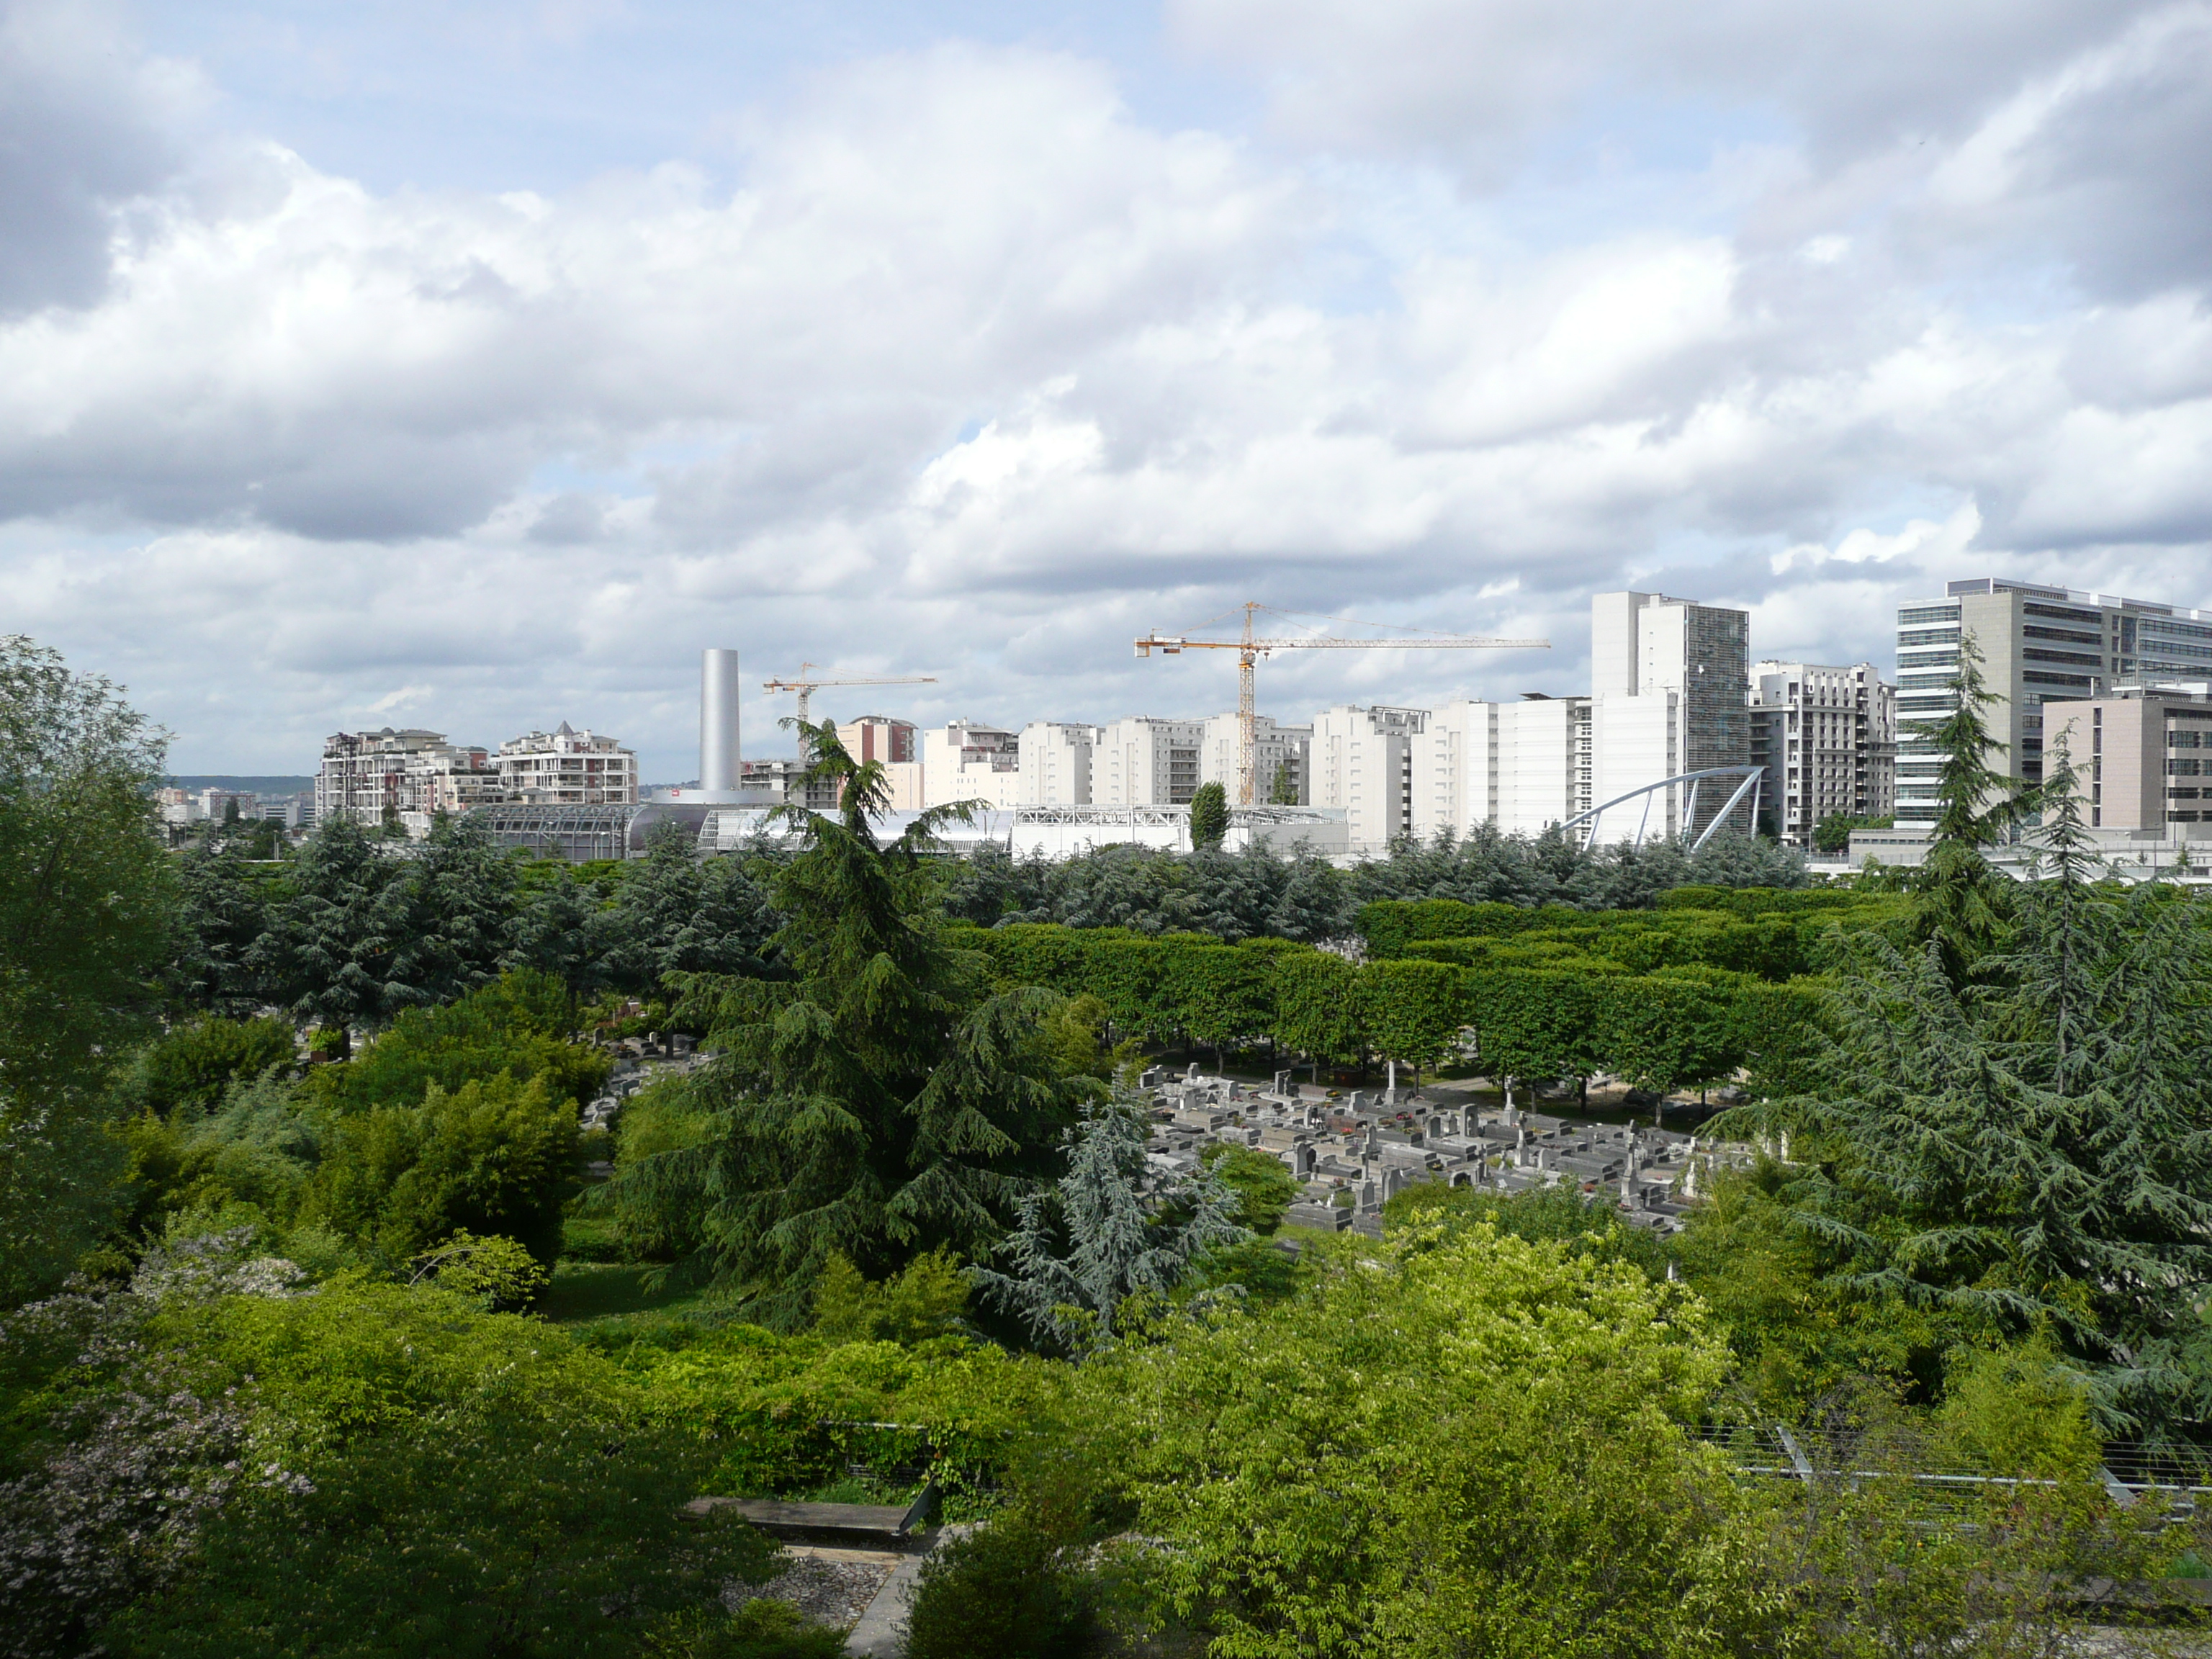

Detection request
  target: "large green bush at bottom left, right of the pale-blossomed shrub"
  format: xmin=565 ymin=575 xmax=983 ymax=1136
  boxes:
xmin=102 ymin=1281 xmax=770 ymax=1659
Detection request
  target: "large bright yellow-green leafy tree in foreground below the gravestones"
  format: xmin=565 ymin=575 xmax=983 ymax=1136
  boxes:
xmin=1069 ymin=1226 xmax=1763 ymax=1655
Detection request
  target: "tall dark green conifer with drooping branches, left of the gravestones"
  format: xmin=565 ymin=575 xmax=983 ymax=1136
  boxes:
xmin=604 ymin=721 xmax=1082 ymax=1325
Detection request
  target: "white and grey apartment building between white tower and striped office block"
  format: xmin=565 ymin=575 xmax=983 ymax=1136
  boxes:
xmin=1752 ymin=662 xmax=1898 ymax=850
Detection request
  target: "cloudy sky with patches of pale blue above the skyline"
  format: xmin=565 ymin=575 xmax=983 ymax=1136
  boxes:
xmin=0 ymin=0 xmax=2212 ymax=781
